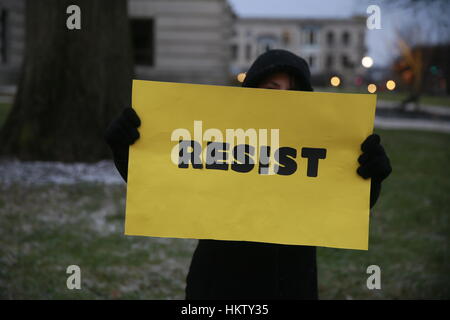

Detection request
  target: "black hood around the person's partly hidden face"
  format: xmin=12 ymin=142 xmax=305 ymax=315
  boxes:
xmin=242 ymin=49 xmax=313 ymax=91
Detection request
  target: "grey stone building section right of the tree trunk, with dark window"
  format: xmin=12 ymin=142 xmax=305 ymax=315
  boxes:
xmin=128 ymin=0 xmax=235 ymax=85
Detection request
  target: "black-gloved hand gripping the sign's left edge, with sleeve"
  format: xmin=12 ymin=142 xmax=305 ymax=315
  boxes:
xmin=105 ymin=108 xmax=141 ymax=181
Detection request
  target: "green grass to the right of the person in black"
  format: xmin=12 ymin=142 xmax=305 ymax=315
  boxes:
xmin=318 ymin=130 xmax=450 ymax=299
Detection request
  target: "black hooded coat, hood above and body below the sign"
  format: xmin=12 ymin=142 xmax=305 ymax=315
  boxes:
xmin=186 ymin=50 xmax=318 ymax=300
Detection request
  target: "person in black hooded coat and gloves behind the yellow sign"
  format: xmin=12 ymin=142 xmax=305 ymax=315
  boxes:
xmin=105 ymin=50 xmax=392 ymax=299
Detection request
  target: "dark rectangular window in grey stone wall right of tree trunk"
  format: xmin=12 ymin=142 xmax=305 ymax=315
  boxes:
xmin=131 ymin=18 xmax=155 ymax=66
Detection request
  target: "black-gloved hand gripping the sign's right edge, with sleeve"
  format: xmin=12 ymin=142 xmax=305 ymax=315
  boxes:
xmin=357 ymin=134 xmax=392 ymax=208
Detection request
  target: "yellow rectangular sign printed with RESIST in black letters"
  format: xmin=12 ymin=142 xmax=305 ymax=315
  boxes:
xmin=125 ymin=80 xmax=376 ymax=250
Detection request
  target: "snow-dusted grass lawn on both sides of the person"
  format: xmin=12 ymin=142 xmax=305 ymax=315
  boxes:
xmin=0 ymin=130 xmax=450 ymax=299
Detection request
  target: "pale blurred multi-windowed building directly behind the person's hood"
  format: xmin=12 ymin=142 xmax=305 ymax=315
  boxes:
xmin=231 ymin=17 xmax=367 ymax=86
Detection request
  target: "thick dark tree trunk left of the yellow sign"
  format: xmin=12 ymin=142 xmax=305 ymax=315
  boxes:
xmin=0 ymin=0 xmax=132 ymax=161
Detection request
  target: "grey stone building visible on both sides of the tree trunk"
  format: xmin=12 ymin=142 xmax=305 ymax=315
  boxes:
xmin=0 ymin=0 xmax=235 ymax=88
